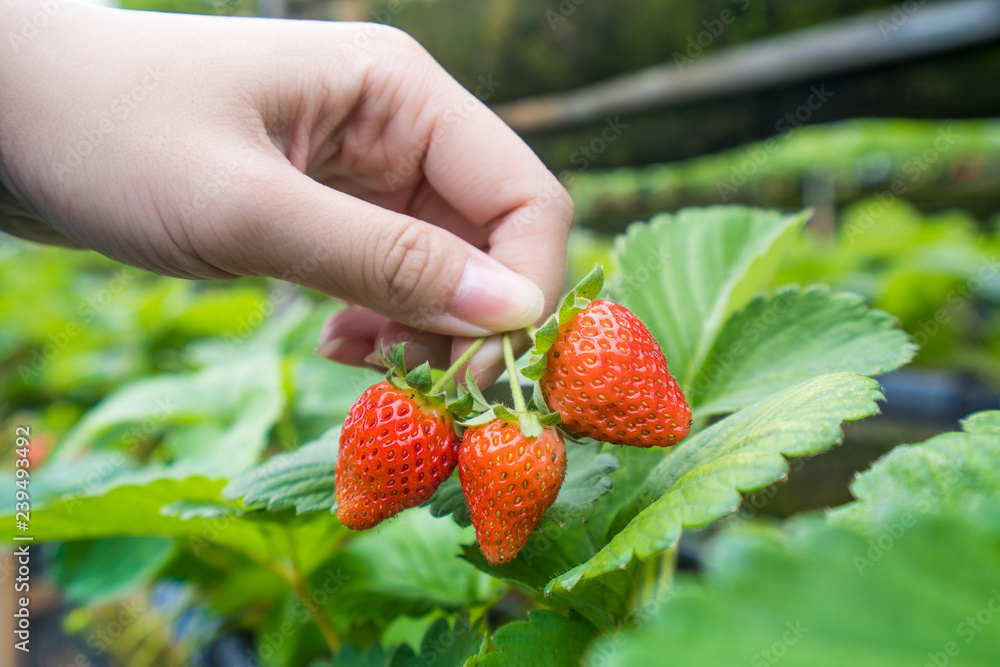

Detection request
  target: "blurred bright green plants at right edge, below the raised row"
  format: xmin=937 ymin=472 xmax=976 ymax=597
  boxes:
xmin=778 ymin=197 xmax=1000 ymax=380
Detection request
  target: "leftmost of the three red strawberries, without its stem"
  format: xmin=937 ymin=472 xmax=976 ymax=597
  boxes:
xmin=336 ymin=382 xmax=459 ymax=530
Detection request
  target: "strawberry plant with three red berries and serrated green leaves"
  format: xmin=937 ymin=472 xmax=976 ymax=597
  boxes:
xmin=9 ymin=207 xmax=1000 ymax=667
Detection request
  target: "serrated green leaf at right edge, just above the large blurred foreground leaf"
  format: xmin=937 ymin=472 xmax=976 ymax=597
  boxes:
xmin=832 ymin=410 xmax=1000 ymax=528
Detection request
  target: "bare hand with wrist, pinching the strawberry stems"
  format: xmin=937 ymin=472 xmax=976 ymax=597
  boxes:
xmin=0 ymin=0 xmax=572 ymax=384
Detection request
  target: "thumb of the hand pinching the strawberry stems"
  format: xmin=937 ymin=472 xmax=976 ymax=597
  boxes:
xmin=209 ymin=165 xmax=545 ymax=337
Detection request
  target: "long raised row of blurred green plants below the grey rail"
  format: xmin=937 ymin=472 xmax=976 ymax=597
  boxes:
xmin=563 ymin=119 xmax=1000 ymax=232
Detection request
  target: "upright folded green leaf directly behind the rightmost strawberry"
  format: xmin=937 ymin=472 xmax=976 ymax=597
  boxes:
xmin=612 ymin=206 xmax=809 ymax=395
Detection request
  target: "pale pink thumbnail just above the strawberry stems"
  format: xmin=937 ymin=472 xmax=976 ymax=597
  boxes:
xmin=450 ymin=257 xmax=545 ymax=331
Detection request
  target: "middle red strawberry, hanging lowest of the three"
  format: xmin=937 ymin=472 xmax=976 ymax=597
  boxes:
xmin=458 ymin=419 xmax=566 ymax=565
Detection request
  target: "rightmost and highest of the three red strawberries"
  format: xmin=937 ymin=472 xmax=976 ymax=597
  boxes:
xmin=540 ymin=300 xmax=691 ymax=447
